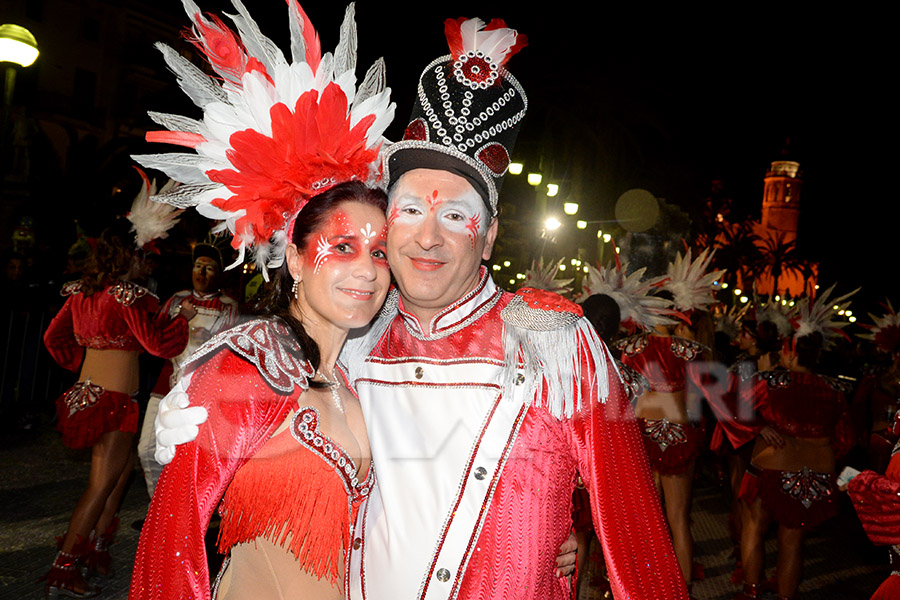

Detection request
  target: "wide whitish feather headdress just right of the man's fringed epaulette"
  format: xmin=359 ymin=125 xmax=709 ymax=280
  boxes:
xmin=581 ymin=263 xmax=677 ymax=329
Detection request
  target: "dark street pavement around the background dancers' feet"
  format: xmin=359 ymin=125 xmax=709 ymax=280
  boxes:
xmin=0 ymin=426 xmax=889 ymax=600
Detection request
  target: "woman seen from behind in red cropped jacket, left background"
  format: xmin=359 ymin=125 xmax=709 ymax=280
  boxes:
xmin=44 ymin=219 xmax=194 ymax=598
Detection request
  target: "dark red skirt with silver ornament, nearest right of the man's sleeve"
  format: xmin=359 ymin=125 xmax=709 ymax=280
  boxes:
xmin=638 ymin=418 xmax=703 ymax=475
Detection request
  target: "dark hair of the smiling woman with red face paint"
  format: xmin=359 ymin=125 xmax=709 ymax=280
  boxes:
xmin=250 ymin=181 xmax=387 ymax=378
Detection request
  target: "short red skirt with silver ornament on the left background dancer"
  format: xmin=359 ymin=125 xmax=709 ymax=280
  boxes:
xmin=56 ymin=380 xmax=139 ymax=448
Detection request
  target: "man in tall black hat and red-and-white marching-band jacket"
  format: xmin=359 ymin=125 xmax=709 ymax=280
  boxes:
xmin=158 ymin=19 xmax=687 ymax=600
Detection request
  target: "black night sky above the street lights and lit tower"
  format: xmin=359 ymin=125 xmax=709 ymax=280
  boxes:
xmin=146 ymin=0 xmax=900 ymax=308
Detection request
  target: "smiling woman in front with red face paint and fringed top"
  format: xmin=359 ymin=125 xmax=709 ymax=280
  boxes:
xmin=131 ymin=182 xmax=390 ymax=600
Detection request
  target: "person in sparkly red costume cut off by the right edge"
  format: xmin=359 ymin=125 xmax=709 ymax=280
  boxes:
xmin=842 ymin=414 xmax=900 ymax=600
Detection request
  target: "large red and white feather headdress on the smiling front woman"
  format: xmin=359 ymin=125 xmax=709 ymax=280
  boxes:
xmin=134 ymin=0 xmax=394 ymax=274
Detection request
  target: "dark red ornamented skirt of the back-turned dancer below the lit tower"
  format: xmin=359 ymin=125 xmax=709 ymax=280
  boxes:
xmin=738 ymin=464 xmax=838 ymax=529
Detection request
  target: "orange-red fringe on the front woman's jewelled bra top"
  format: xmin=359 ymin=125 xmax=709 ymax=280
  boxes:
xmin=219 ymin=431 xmax=353 ymax=585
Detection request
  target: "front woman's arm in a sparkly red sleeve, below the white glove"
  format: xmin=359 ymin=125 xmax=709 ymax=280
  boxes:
xmin=130 ymin=349 xmax=292 ymax=600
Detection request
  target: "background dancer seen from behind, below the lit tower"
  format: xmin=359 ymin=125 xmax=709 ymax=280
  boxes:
xmin=722 ymin=326 xmax=852 ymax=600
